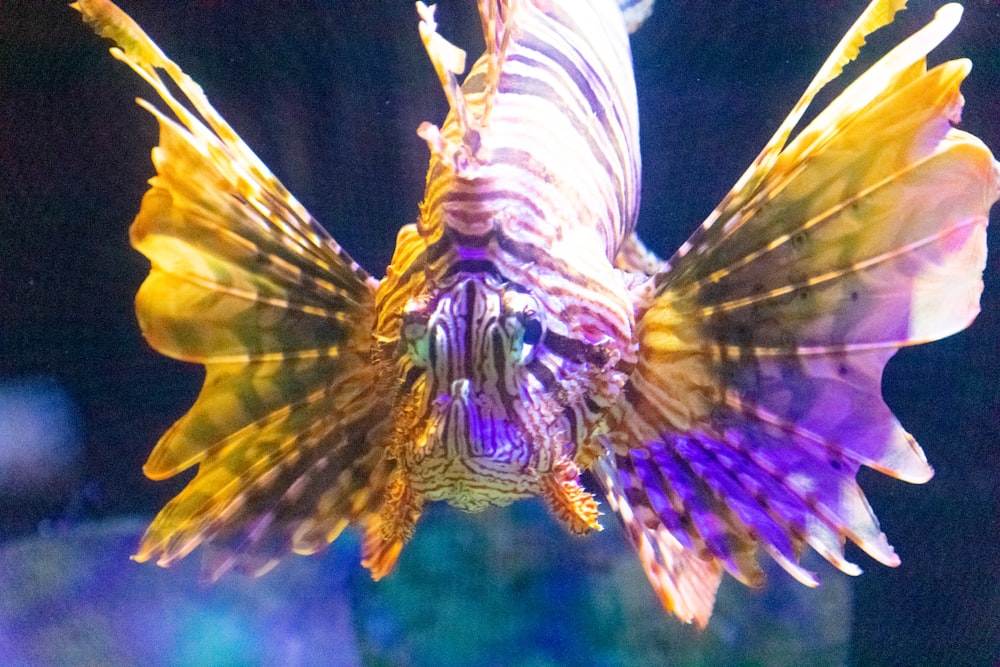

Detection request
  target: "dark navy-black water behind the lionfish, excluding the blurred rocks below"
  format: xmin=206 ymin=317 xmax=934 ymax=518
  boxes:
xmin=0 ymin=0 xmax=1000 ymax=665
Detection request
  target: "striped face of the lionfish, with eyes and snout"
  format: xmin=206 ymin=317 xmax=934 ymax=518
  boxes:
xmin=400 ymin=274 xmax=557 ymax=509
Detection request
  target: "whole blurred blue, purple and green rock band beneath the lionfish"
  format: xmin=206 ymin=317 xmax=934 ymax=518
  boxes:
xmin=0 ymin=502 xmax=851 ymax=665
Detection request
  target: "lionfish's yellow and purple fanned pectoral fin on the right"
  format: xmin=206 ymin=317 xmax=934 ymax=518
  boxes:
xmin=597 ymin=2 xmax=998 ymax=625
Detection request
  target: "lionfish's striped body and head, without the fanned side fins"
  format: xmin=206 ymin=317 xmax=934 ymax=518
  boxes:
xmin=376 ymin=0 xmax=639 ymax=520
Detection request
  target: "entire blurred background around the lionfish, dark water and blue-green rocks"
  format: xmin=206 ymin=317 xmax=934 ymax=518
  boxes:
xmin=0 ymin=0 xmax=1000 ymax=665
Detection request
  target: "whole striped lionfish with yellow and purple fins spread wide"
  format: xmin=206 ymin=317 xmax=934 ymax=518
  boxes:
xmin=73 ymin=0 xmax=1000 ymax=625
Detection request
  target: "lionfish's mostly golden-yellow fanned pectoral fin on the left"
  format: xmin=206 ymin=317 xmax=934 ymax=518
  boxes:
xmin=74 ymin=0 xmax=387 ymax=578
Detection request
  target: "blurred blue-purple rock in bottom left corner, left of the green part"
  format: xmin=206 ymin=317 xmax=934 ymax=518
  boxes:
xmin=0 ymin=520 xmax=359 ymax=666
